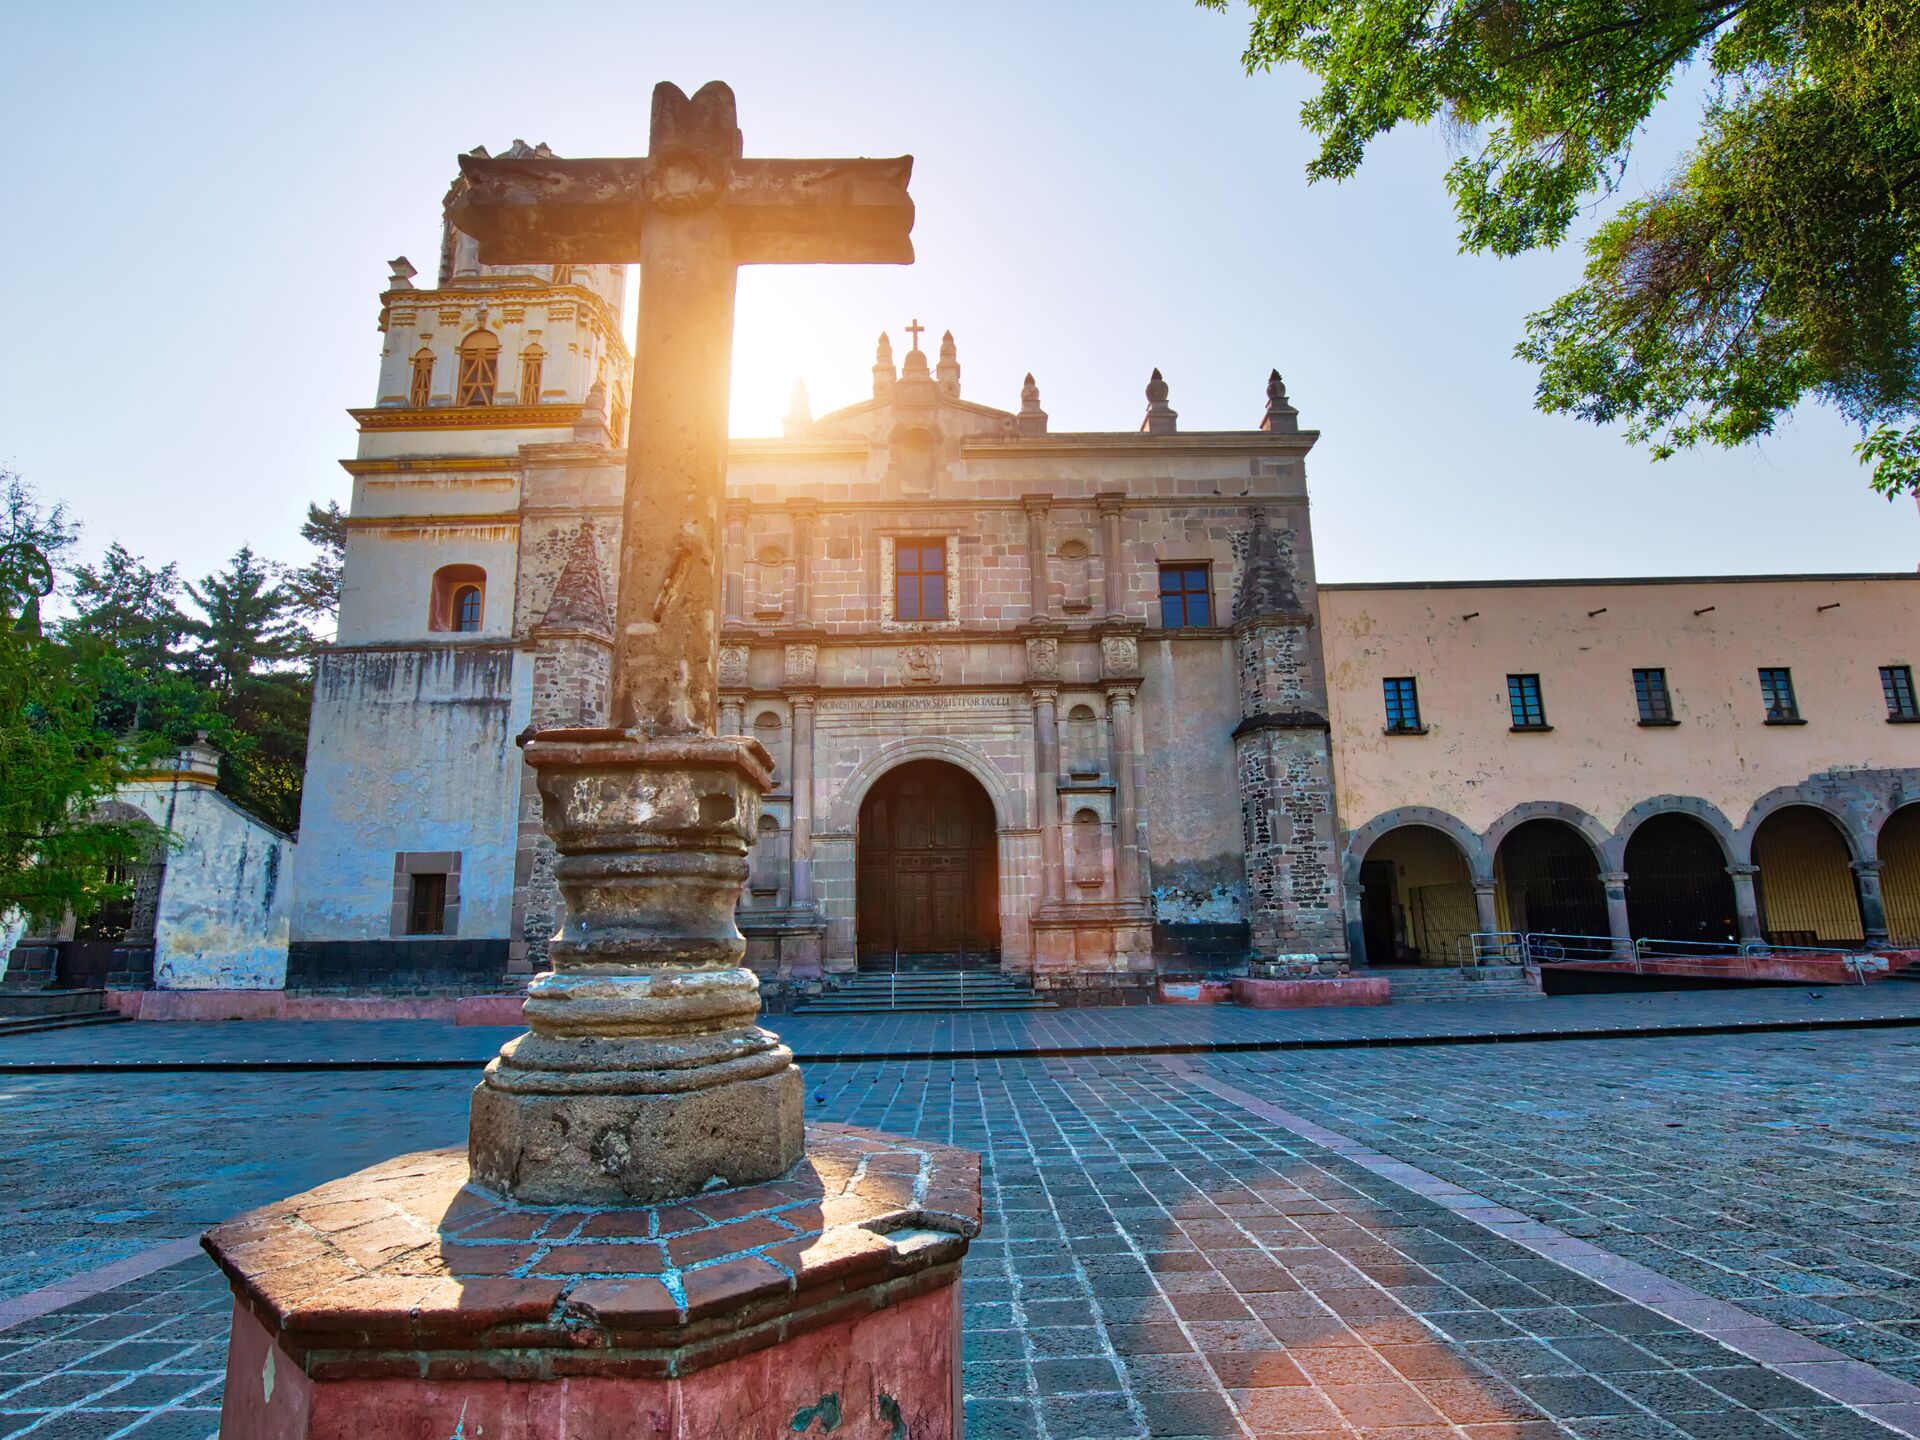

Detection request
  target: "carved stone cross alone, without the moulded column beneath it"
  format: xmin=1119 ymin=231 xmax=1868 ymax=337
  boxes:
xmin=451 ymin=81 xmax=914 ymax=735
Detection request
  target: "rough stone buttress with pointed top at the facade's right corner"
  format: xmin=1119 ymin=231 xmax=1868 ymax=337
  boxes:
xmin=1233 ymin=374 xmax=1348 ymax=972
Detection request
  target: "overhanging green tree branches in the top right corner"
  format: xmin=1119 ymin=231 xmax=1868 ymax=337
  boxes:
xmin=1200 ymin=0 xmax=1920 ymax=495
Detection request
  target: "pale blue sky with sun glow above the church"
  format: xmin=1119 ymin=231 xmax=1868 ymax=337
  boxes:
xmin=0 ymin=0 xmax=1920 ymax=580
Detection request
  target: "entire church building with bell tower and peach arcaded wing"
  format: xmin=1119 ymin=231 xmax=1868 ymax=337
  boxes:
xmin=284 ymin=163 xmax=1920 ymax=998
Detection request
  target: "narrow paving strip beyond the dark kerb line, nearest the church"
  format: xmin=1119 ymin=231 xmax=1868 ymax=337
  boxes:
xmin=0 ymin=981 xmax=1920 ymax=1066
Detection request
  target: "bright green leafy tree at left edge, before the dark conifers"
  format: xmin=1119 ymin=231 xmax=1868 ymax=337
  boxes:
xmin=0 ymin=474 xmax=152 ymax=922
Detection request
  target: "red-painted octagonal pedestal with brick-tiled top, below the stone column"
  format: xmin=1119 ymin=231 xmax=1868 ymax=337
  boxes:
xmin=205 ymin=1125 xmax=979 ymax=1440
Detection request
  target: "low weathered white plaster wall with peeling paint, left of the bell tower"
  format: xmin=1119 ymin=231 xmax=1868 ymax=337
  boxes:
xmin=115 ymin=781 xmax=296 ymax=991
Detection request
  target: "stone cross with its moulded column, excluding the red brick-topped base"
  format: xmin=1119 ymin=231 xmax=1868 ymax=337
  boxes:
xmin=449 ymin=83 xmax=914 ymax=1204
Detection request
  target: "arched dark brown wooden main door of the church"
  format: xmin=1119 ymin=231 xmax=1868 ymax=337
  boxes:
xmin=856 ymin=760 xmax=1000 ymax=970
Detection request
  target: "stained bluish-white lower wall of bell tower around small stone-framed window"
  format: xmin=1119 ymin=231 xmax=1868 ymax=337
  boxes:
xmin=292 ymin=645 xmax=530 ymax=941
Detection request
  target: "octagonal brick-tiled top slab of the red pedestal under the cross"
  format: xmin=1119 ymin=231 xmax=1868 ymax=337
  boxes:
xmin=205 ymin=1125 xmax=979 ymax=1394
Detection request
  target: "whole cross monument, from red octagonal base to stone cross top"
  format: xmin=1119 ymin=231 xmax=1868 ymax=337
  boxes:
xmin=205 ymin=84 xmax=979 ymax=1440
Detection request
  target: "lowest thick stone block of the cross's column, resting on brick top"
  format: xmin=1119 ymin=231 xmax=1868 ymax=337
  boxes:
xmin=467 ymin=1064 xmax=806 ymax=1206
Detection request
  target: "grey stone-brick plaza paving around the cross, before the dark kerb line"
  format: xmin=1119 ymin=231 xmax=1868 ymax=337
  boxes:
xmin=0 ymin=1002 xmax=1920 ymax=1440
